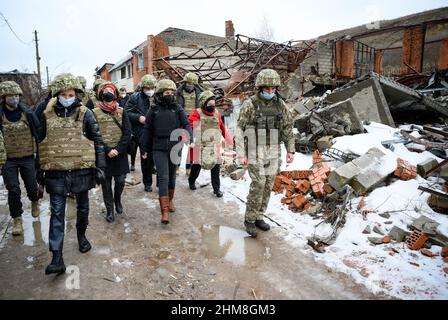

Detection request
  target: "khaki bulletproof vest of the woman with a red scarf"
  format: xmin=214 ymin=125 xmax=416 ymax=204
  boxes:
xmin=93 ymin=107 xmax=123 ymax=148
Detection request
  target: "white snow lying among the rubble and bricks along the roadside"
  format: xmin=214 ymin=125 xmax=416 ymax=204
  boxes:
xmin=219 ymin=123 xmax=448 ymax=299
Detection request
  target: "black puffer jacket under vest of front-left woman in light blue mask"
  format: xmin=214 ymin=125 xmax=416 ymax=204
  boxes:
xmin=36 ymin=100 xmax=106 ymax=195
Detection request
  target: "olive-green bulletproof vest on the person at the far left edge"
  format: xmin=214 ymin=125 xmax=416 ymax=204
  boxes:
xmin=2 ymin=112 xmax=36 ymax=159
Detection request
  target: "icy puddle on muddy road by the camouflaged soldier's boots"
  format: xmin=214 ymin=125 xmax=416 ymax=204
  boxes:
xmin=201 ymin=225 xmax=269 ymax=267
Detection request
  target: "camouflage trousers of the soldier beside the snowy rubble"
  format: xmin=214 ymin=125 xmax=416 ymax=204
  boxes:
xmin=245 ymin=159 xmax=280 ymax=222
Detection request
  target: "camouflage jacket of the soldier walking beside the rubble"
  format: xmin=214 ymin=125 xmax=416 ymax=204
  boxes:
xmin=235 ymin=93 xmax=295 ymax=157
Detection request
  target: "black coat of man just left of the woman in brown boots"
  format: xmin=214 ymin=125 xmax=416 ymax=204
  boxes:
xmin=125 ymin=92 xmax=151 ymax=143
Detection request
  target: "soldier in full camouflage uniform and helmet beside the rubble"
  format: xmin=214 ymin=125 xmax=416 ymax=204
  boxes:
xmin=236 ymin=69 xmax=295 ymax=237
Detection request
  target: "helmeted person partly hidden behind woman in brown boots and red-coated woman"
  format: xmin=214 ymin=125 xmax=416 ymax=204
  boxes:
xmin=176 ymin=72 xmax=202 ymax=176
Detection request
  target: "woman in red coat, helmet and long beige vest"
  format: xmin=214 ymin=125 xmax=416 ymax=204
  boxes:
xmin=188 ymin=90 xmax=233 ymax=198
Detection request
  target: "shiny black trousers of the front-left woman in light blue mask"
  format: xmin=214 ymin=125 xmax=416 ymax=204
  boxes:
xmin=48 ymin=191 xmax=89 ymax=251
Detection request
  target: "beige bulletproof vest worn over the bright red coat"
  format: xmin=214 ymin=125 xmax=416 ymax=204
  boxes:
xmin=198 ymin=109 xmax=221 ymax=170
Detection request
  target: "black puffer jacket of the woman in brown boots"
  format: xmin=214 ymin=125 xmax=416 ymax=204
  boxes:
xmin=142 ymin=99 xmax=193 ymax=153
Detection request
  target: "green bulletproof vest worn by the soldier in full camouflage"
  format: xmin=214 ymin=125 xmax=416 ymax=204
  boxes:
xmin=251 ymin=96 xmax=283 ymax=145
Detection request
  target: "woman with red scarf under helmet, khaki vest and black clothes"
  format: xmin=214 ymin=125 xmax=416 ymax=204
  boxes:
xmin=93 ymin=82 xmax=131 ymax=222
